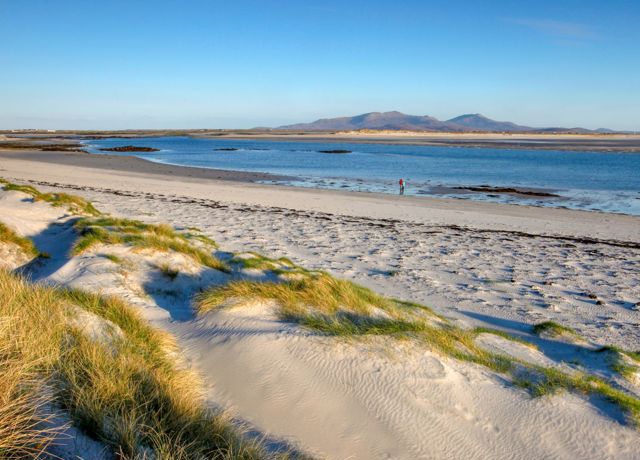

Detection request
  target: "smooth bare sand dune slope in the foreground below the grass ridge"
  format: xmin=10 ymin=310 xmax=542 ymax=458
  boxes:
xmin=175 ymin=305 xmax=638 ymax=459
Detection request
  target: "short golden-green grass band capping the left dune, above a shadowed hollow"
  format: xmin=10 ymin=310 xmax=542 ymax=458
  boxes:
xmin=72 ymin=217 xmax=229 ymax=272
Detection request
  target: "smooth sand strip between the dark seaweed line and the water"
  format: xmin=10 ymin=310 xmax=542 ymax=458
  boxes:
xmin=0 ymin=150 xmax=640 ymax=242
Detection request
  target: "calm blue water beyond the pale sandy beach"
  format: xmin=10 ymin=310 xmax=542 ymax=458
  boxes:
xmin=87 ymin=137 xmax=640 ymax=215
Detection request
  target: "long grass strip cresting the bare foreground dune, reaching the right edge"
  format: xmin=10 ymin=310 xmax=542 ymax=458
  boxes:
xmin=196 ymin=272 xmax=640 ymax=424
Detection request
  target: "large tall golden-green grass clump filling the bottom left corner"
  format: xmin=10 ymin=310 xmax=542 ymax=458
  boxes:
xmin=0 ymin=271 xmax=266 ymax=459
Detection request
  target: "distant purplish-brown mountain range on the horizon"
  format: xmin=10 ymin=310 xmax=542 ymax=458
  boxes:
xmin=276 ymin=111 xmax=613 ymax=133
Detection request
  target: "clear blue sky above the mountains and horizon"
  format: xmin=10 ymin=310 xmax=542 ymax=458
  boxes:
xmin=0 ymin=0 xmax=640 ymax=131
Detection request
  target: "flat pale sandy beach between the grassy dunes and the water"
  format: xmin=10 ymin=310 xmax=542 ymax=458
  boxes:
xmin=0 ymin=154 xmax=640 ymax=349
